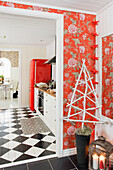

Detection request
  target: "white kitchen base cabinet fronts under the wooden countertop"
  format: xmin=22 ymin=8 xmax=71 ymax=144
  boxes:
xmin=35 ymin=88 xmax=56 ymax=135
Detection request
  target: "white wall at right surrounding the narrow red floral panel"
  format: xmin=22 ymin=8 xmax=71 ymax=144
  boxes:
xmin=97 ymin=1 xmax=113 ymax=149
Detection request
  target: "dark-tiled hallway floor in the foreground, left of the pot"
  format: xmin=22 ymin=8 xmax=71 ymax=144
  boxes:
xmin=0 ymin=155 xmax=113 ymax=170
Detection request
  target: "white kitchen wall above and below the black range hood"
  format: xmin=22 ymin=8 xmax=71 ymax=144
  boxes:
xmin=46 ymin=42 xmax=56 ymax=80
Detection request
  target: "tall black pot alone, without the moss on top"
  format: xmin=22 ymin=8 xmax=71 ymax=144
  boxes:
xmin=76 ymin=134 xmax=90 ymax=168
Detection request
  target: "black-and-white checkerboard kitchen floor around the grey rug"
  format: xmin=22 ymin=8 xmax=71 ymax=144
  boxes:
xmin=0 ymin=108 xmax=56 ymax=165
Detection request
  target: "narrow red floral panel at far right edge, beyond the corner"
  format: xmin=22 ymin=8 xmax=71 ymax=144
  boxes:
xmin=102 ymin=34 xmax=113 ymax=119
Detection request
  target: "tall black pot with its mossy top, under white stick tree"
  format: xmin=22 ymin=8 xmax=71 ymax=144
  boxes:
xmin=75 ymin=126 xmax=92 ymax=168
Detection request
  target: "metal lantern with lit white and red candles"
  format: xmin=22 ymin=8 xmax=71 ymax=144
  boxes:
xmin=89 ymin=136 xmax=113 ymax=170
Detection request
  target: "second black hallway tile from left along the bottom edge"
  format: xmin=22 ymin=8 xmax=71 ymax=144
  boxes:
xmin=28 ymin=161 xmax=52 ymax=170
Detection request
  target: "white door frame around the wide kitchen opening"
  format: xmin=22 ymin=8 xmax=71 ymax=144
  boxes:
xmin=0 ymin=6 xmax=64 ymax=167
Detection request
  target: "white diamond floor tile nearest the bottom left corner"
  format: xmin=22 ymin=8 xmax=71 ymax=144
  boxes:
xmin=1 ymin=150 xmax=22 ymax=161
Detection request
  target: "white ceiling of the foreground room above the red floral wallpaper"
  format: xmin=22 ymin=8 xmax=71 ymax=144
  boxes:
xmin=1 ymin=0 xmax=113 ymax=12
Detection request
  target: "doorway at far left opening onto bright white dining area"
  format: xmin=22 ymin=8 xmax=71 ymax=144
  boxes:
xmin=0 ymin=49 xmax=21 ymax=109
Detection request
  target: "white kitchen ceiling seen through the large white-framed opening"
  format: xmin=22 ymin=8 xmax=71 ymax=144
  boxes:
xmin=0 ymin=14 xmax=56 ymax=46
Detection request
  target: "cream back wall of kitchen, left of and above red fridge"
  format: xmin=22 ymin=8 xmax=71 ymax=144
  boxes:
xmin=0 ymin=44 xmax=46 ymax=106
